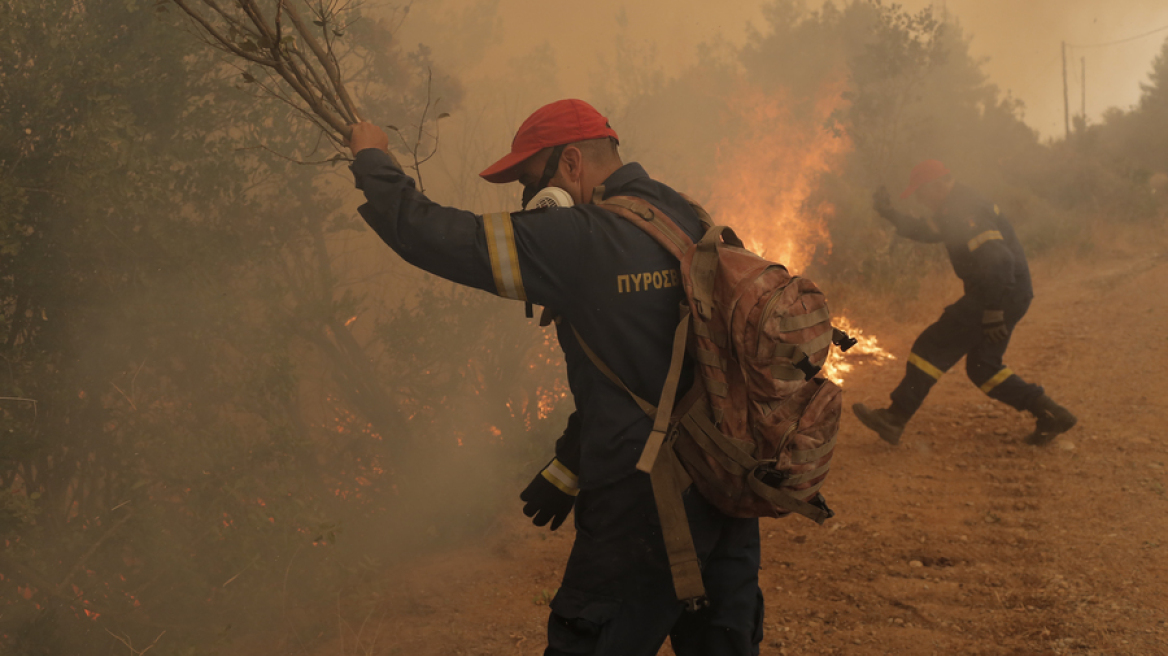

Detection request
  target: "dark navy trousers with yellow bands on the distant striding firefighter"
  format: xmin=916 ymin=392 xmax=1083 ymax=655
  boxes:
xmin=892 ymin=295 xmax=1043 ymax=417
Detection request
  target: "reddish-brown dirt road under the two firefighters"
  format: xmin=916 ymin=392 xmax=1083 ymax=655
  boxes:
xmin=306 ymin=242 xmax=1168 ymax=656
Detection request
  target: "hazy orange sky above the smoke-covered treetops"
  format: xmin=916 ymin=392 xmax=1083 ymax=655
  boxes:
xmin=402 ymin=0 xmax=1168 ymax=137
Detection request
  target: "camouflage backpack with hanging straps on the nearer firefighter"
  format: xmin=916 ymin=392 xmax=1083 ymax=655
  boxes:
xmin=577 ymin=194 xmax=842 ymax=609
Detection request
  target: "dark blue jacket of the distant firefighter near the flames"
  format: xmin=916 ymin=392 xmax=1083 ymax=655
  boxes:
xmin=892 ymin=183 xmax=1034 ymax=309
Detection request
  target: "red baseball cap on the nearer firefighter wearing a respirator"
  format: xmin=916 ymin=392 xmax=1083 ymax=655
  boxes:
xmin=479 ymin=99 xmax=617 ymax=182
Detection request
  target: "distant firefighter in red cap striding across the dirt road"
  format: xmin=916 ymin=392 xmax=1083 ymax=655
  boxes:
xmin=853 ymin=160 xmax=1076 ymax=446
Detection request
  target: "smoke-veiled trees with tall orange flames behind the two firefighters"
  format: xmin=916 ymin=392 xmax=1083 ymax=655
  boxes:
xmin=617 ymin=0 xmax=1168 ymax=298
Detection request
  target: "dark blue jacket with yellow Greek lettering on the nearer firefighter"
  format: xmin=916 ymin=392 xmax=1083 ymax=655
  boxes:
xmin=353 ymin=149 xmax=701 ymax=489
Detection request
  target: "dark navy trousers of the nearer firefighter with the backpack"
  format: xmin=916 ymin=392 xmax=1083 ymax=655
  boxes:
xmin=544 ymin=472 xmax=763 ymax=656
